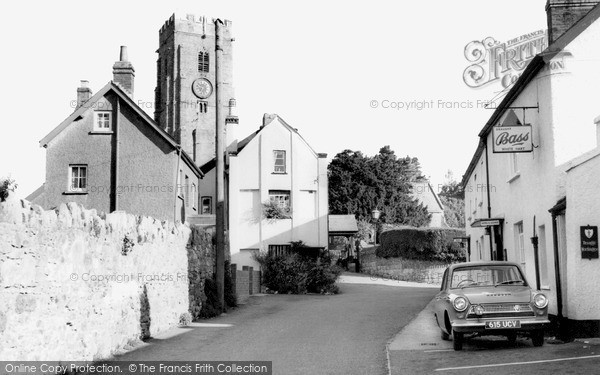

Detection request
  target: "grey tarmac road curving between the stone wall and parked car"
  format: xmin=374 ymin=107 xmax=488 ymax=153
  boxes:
xmin=111 ymin=277 xmax=436 ymax=375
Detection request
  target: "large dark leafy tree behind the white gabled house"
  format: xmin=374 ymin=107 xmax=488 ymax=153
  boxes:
xmin=328 ymin=146 xmax=431 ymax=226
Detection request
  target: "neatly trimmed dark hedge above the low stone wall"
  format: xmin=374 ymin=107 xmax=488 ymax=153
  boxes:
xmin=375 ymin=227 xmax=466 ymax=263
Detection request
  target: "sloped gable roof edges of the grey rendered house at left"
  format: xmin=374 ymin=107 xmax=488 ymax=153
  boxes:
xmin=40 ymin=81 xmax=204 ymax=177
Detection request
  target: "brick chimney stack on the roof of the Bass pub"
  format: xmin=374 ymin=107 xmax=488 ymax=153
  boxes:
xmin=546 ymin=0 xmax=600 ymax=44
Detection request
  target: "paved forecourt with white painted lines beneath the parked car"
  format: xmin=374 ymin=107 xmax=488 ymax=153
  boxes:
xmin=387 ymin=302 xmax=600 ymax=375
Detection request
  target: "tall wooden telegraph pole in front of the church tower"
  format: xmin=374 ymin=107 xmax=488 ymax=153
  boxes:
xmin=214 ymin=19 xmax=225 ymax=309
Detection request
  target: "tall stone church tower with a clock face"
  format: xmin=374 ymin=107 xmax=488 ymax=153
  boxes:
xmin=154 ymin=14 xmax=238 ymax=166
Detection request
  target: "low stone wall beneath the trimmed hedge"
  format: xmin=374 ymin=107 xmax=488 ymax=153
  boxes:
xmin=360 ymin=247 xmax=448 ymax=285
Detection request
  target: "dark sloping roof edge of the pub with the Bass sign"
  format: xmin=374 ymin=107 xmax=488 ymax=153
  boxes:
xmin=461 ymin=4 xmax=600 ymax=187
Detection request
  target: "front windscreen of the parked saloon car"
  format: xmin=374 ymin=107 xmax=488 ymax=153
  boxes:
xmin=450 ymin=265 xmax=526 ymax=288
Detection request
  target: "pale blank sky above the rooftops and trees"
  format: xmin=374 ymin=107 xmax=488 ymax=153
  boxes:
xmin=0 ymin=0 xmax=546 ymax=196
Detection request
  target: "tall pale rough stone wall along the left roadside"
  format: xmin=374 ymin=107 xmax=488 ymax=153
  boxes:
xmin=0 ymin=196 xmax=214 ymax=361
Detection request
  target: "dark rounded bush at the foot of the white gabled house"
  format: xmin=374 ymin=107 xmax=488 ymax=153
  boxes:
xmin=254 ymin=252 xmax=342 ymax=294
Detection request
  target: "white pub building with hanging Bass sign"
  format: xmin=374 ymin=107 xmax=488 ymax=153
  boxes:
xmin=462 ymin=0 xmax=600 ymax=337
